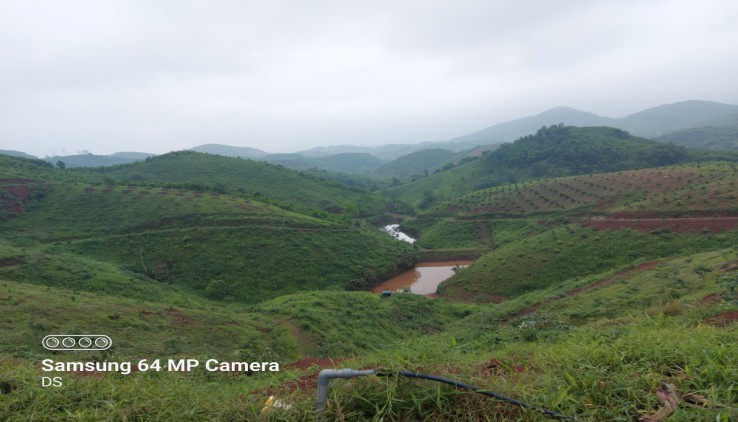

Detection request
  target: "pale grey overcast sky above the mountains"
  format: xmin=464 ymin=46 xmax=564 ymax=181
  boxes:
xmin=0 ymin=0 xmax=738 ymax=156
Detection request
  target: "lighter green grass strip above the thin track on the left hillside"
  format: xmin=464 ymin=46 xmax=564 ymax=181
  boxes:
xmin=3 ymin=183 xmax=331 ymax=242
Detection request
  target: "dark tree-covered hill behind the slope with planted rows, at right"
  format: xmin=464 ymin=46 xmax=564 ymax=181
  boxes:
xmin=381 ymin=126 xmax=738 ymax=208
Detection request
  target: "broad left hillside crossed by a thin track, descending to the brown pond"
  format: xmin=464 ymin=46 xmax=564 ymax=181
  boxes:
xmin=0 ymin=157 xmax=416 ymax=302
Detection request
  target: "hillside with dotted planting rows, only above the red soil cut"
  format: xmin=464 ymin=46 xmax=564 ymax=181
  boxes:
xmin=428 ymin=163 xmax=738 ymax=218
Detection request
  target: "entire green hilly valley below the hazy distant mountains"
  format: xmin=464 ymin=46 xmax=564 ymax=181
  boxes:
xmin=0 ymin=120 xmax=738 ymax=421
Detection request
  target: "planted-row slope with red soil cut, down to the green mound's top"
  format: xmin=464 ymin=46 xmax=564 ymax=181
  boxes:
xmin=402 ymin=162 xmax=738 ymax=264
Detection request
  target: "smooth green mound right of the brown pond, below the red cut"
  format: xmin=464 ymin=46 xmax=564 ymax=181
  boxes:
xmin=439 ymin=225 xmax=738 ymax=300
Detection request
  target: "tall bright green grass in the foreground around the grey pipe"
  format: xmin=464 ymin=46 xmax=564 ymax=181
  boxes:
xmin=0 ymin=311 xmax=738 ymax=421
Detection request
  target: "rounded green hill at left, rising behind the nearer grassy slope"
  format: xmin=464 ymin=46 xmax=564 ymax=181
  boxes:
xmin=79 ymin=152 xmax=388 ymax=215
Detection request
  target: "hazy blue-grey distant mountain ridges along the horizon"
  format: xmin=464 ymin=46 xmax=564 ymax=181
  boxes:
xmin=11 ymin=100 xmax=738 ymax=171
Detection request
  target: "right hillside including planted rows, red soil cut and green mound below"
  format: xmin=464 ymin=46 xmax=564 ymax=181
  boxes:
xmin=396 ymin=162 xmax=738 ymax=302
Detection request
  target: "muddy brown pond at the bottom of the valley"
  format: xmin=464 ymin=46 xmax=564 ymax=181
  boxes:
xmin=372 ymin=261 xmax=472 ymax=296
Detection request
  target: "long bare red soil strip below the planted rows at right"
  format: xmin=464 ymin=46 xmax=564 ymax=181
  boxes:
xmin=581 ymin=217 xmax=738 ymax=233
